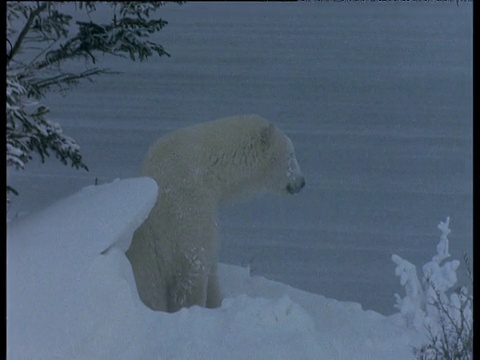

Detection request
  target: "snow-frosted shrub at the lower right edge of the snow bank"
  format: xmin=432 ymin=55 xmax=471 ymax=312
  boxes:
xmin=392 ymin=217 xmax=473 ymax=360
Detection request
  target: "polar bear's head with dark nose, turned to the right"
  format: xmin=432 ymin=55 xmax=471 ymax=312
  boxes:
xmin=260 ymin=123 xmax=305 ymax=194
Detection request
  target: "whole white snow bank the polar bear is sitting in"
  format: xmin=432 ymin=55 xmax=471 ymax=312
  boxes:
xmin=7 ymin=178 xmax=419 ymax=359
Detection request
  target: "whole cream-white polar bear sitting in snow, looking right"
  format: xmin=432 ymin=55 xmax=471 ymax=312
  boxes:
xmin=126 ymin=115 xmax=305 ymax=312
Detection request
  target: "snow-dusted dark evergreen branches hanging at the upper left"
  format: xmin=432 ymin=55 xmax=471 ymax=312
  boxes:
xmin=6 ymin=1 xmax=179 ymax=201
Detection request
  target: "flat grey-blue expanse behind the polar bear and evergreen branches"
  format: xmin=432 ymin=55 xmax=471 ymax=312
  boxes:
xmin=7 ymin=2 xmax=473 ymax=315
